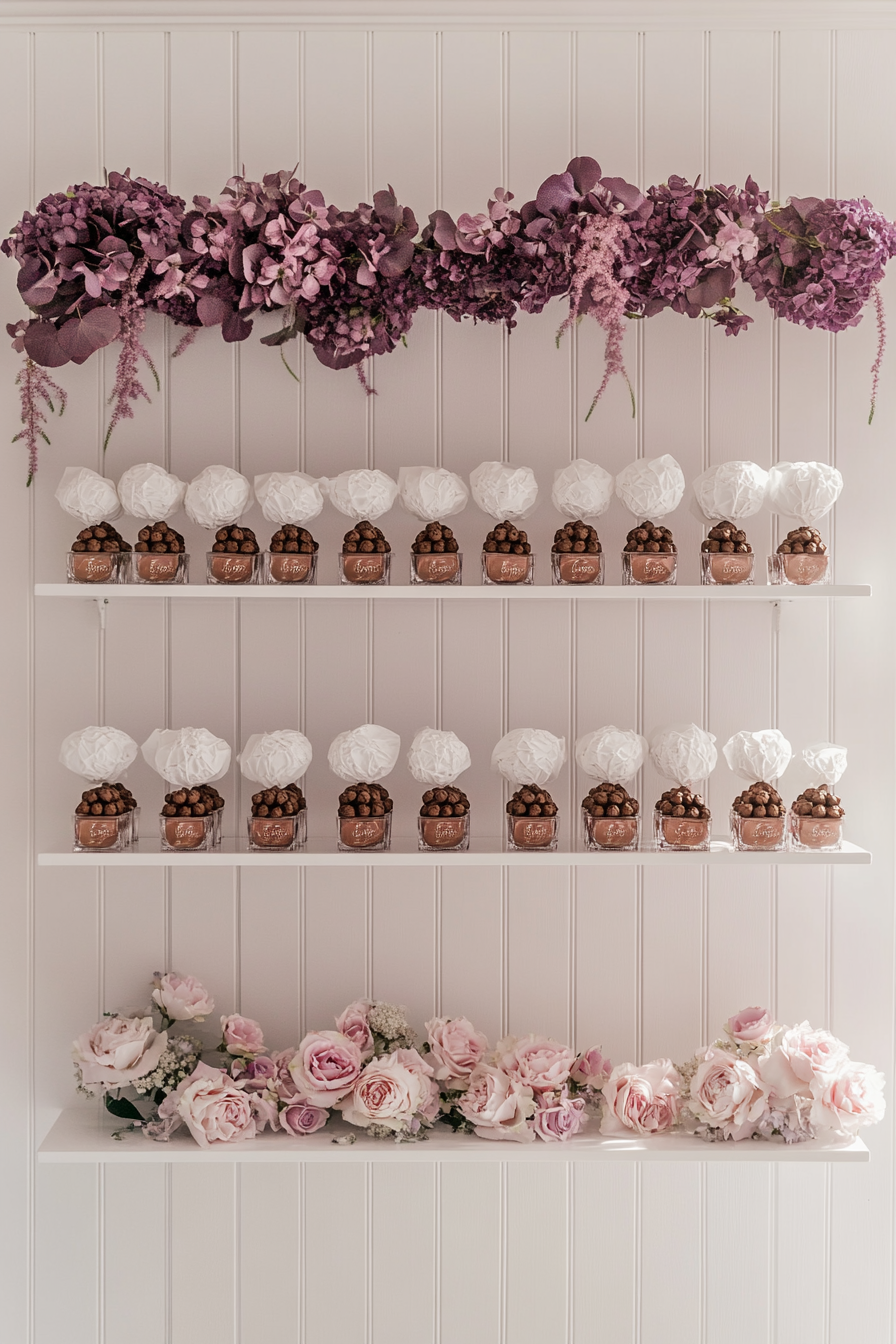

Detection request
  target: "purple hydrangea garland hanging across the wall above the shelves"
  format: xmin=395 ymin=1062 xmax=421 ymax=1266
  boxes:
xmin=1 ymin=157 xmax=896 ymax=484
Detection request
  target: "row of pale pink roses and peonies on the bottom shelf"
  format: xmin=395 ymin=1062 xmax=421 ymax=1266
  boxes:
xmin=73 ymin=972 xmax=884 ymax=1148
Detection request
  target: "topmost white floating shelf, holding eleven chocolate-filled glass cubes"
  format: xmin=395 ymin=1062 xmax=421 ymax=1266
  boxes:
xmin=35 ymin=583 xmax=870 ymax=602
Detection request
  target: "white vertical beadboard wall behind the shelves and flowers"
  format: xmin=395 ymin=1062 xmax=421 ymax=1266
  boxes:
xmin=0 ymin=3 xmax=896 ymax=1344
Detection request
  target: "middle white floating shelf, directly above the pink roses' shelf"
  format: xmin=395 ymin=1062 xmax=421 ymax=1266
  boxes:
xmin=38 ymin=837 xmax=870 ymax=868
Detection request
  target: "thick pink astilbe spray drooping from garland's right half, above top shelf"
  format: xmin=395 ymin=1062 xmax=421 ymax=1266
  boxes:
xmin=557 ymin=215 xmax=634 ymax=421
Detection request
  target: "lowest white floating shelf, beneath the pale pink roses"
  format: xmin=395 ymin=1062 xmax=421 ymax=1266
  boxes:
xmin=38 ymin=1102 xmax=870 ymax=1165
